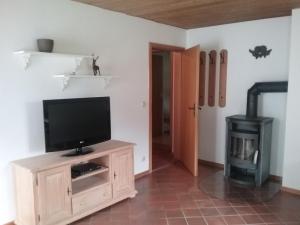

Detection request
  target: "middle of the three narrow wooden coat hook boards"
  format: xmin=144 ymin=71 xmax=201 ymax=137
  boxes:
xmin=208 ymin=50 xmax=217 ymax=107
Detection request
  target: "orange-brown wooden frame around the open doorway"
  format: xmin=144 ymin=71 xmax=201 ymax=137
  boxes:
xmin=148 ymin=42 xmax=185 ymax=173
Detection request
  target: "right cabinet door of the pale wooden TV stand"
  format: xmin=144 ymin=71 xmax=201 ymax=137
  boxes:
xmin=112 ymin=149 xmax=134 ymax=198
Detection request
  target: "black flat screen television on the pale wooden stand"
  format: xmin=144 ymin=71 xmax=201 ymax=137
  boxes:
xmin=43 ymin=97 xmax=111 ymax=156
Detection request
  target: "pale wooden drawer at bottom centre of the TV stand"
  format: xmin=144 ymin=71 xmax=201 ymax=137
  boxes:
xmin=72 ymin=184 xmax=112 ymax=214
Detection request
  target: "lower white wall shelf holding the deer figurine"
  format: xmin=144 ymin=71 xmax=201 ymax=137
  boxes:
xmin=53 ymin=74 xmax=117 ymax=90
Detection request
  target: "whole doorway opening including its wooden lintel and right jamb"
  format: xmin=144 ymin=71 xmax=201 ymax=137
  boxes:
xmin=149 ymin=43 xmax=185 ymax=172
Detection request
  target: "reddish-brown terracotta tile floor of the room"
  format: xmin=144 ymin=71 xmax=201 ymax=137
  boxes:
xmin=74 ymin=164 xmax=300 ymax=225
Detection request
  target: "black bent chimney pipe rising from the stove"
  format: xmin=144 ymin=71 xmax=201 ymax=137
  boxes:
xmin=246 ymin=81 xmax=288 ymax=118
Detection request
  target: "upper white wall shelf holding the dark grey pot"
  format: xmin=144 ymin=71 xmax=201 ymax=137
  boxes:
xmin=14 ymin=50 xmax=93 ymax=71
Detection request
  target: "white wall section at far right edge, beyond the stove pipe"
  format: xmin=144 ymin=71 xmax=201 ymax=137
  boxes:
xmin=283 ymin=9 xmax=300 ymax=190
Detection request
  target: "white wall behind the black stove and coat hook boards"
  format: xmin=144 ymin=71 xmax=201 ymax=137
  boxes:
xmin=187 ymin=17 xmax=290 ymax=176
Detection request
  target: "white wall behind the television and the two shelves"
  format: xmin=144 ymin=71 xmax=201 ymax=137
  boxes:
xmin=0 ymin=0 xmax=185 ymax=221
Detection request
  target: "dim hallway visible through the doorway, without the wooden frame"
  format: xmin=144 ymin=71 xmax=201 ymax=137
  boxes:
xmin=152 ymin=49 xmax=173 ymax=170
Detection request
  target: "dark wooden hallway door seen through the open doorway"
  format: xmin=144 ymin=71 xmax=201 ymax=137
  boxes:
xmin=152 ymin=55 xmax=163 ymax=137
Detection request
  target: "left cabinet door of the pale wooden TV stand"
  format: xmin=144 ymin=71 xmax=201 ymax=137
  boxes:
xmin=38 ymin=166 xmax=71 ymax=225
